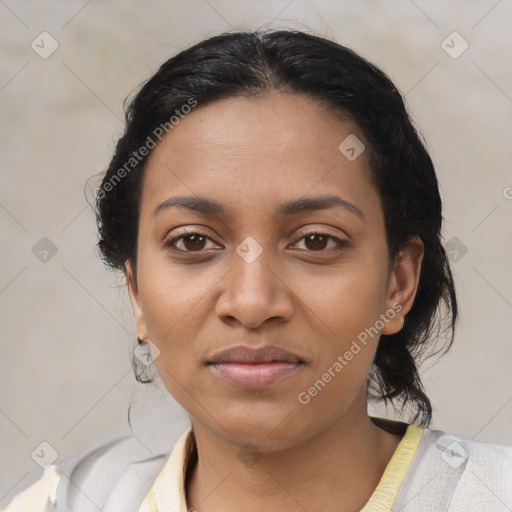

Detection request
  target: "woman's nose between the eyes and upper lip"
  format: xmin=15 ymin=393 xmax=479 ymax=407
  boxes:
xmin=215 ymin=247 xmax=294 ymax=329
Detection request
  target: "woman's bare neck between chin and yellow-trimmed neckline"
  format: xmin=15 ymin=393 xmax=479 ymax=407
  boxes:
xmin=186 ymin=408 xmax=401 ymax=512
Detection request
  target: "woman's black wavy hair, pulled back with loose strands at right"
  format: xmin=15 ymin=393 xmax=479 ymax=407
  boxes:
xmin=96 ymin=30 xmax=458 ymax=426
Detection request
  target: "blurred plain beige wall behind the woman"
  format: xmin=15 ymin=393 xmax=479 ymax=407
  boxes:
xmin=0 ymin=0 xmax=512 ymax=505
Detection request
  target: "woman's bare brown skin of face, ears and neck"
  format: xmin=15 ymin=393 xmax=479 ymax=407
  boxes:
xmin=126 ymin=93 xmax=424 ymax=512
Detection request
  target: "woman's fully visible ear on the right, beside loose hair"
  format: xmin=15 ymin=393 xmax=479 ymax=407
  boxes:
xmin=382 ymin=236 xmax=425 ymax=334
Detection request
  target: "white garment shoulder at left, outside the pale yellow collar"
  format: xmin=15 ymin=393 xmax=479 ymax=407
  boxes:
xmin=5 ymin=436 xmax=168 ymax=512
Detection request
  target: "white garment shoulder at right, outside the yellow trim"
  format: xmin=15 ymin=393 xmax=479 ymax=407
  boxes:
xmin=393 ymin=429 xmax=512 ymax=512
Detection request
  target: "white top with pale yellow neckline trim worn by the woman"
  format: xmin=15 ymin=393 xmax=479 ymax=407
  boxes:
xmin=5 ymin=422 xmax=512 ymax=512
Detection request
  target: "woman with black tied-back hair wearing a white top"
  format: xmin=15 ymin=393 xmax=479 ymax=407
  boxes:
xmin=7 ymin=31 xmax=512 ymax=512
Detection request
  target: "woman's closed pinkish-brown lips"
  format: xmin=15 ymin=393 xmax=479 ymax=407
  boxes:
xmin=208 ymin=345 xmax=305 ymax=390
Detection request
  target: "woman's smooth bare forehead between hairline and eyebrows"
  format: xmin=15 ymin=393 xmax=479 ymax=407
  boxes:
xmin=141 ymin=94 xmax=376 ymax=224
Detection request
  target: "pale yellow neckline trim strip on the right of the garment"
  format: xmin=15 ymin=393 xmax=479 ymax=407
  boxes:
xmin=360 ymin=425 xmax=423 ymax=512
